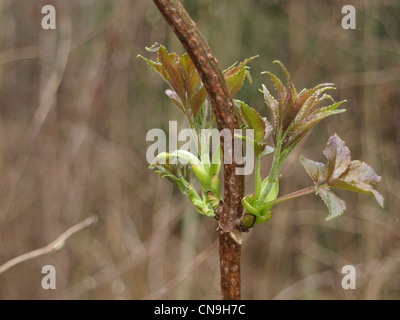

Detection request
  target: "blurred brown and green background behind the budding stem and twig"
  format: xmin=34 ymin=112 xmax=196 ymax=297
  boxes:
xmin=0 ymin=0 xmax=400 ymax=299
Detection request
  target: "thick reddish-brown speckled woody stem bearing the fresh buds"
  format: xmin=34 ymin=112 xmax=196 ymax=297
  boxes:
xmin=154 ymin=0 xmax=244 ymax=299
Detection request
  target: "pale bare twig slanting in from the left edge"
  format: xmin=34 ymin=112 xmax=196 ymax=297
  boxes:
xmin=0 ymin=216 xmax=98 ymax=274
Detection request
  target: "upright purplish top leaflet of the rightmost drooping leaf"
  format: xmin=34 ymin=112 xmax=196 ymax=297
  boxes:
xmin=324 ymin=134 xmax=351 ymax=184
